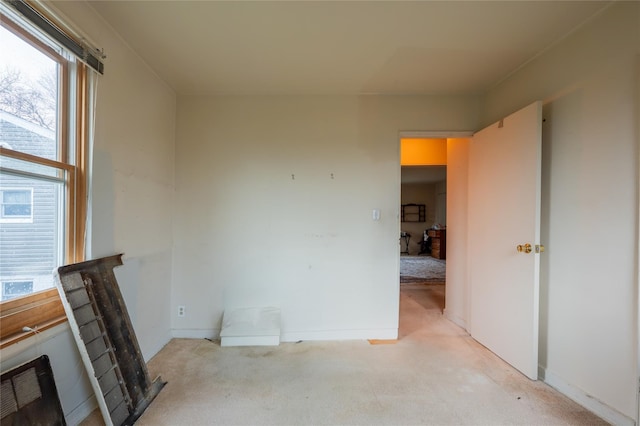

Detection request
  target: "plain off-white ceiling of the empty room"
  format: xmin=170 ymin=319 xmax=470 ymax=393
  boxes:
xmin=84 ymin=0 xmax=610 ymax=95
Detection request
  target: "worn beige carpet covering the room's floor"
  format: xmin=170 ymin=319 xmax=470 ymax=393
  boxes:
xmin=80 ymin=284 xmax=606 ymax=426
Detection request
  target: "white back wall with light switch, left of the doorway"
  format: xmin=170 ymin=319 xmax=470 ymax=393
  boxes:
xmin=172 ymin=96 xmax=477 ymax=341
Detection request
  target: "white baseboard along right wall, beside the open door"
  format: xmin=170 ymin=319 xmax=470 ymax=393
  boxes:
xmin=538 ymin=367 xmax=636 ymax=426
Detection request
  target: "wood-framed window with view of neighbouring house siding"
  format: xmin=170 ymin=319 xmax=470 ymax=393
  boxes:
xmin=0 ymin=1 xmax=102 ymax=348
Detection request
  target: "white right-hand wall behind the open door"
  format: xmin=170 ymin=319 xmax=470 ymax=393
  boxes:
xmin=482 ymin=2 xmax=640 ymax=424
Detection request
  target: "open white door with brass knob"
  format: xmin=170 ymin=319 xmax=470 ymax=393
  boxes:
xmin=468 ymin=102 xmax=542 ymax=380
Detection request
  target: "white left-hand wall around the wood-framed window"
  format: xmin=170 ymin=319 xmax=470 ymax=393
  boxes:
xmin=0 ymin=1 xmax=175 ymax=424
